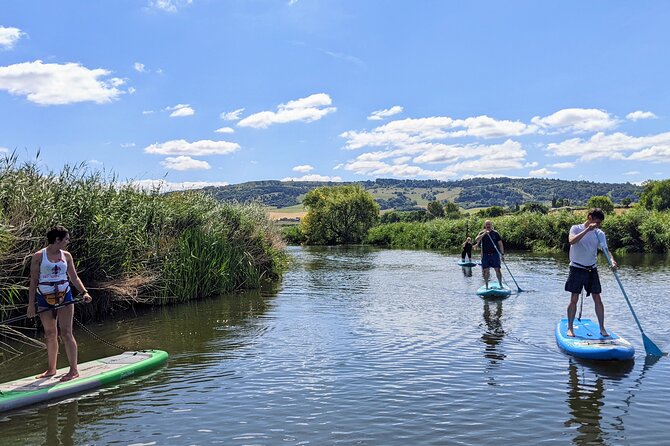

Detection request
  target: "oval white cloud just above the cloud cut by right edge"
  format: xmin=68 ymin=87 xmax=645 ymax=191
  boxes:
xmin=531 ymin=108 xmax=617 ymax=132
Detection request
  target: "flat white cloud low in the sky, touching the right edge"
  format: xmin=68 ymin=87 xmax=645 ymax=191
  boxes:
xmin=547 ymin=132 xmax=670 ymax=163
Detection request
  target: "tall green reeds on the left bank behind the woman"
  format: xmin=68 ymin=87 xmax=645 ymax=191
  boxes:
xmin=0 ymin=157 xmax=287 ymax=316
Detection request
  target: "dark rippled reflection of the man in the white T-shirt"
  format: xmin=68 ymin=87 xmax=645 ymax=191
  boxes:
xmin=565 ymin=359 xmax=634 ymax=446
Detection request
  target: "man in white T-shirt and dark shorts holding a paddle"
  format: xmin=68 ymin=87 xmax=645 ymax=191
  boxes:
xmin=565 ymin=208 xmax=617 ymax=336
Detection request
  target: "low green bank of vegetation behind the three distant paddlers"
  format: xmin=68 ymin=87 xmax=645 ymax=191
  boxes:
xmin=366 ymin=207 xmax=670 ymax=252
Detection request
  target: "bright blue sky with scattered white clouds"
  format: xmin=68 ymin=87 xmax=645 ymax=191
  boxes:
xmin=0 ymin=0 xmax=670 ymax=189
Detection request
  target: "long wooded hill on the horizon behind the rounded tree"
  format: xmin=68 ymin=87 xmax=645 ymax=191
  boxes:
xmin=203 ymin=177 xmax=642 ymax=210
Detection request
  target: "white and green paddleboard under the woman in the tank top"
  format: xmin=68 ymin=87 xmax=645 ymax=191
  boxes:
xmin=0 ymin=350 xmax=168 ymax=412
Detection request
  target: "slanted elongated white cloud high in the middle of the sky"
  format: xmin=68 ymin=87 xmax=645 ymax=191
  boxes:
xmin=237 ymin=93 xmax=337 ymax=128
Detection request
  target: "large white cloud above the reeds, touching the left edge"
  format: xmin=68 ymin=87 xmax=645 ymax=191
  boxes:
xmin=0 ymin=60 xmax=125 ymax=105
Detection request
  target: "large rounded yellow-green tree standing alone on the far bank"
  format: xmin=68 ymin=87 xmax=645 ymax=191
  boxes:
xmin=300 ymin=185 xmax=379 ymax=245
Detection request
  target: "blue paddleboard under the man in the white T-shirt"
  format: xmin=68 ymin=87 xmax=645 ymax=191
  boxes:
xmin=556 ymin=319 xmax=635 ymax=361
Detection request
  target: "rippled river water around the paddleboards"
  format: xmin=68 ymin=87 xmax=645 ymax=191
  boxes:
xmin=0 ymin=247 xmax=670 ymax=445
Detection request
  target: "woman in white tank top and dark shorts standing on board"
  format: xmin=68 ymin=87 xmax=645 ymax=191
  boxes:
xmin=27 ymin=226 xmax=92 ymax=381
